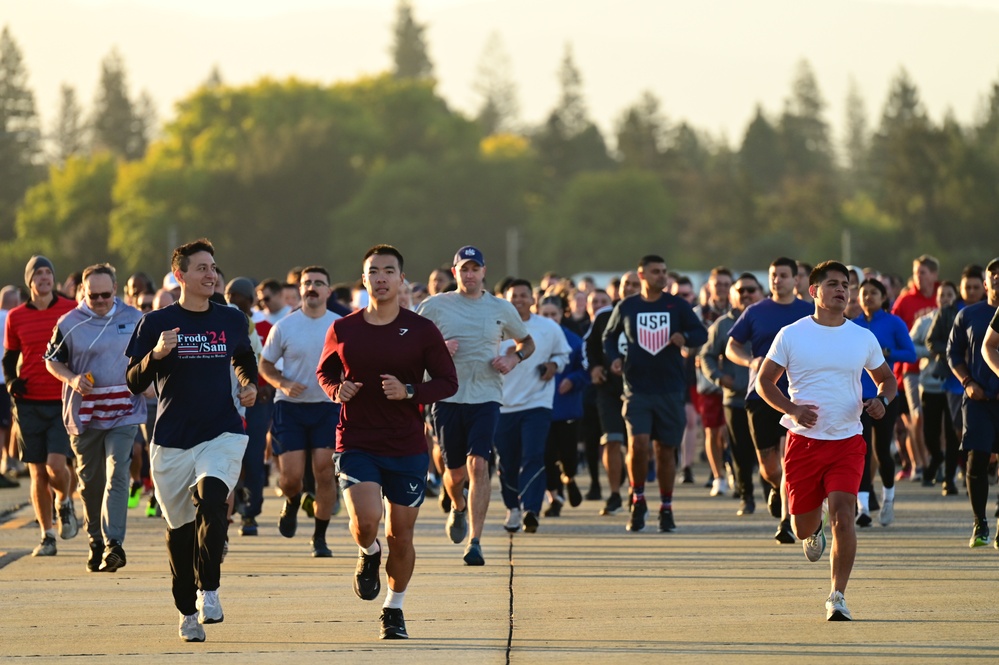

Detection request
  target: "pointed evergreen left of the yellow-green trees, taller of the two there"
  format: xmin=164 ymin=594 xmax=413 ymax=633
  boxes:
xmin=90 ymin=49 xmax=146 ymax=160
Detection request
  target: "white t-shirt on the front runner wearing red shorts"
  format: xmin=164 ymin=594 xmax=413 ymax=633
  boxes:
xmin=767 ymin=316 xmax=885 ymax=440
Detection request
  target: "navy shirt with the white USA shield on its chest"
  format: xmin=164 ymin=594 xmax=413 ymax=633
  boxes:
xmin=603 ymin=293 xmax=708 ymax=395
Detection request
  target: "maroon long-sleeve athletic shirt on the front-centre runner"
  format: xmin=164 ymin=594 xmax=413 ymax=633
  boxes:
xmin=316 ymin=309 xmax=458 ymax=457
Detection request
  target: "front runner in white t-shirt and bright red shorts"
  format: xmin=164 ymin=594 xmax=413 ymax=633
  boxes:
xmin=756 ymin=261 xmax=898 ymax=621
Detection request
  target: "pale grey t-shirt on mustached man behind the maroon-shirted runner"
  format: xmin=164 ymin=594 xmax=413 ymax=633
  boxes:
xmin=262 ymin=309 xmax=340 ymax=404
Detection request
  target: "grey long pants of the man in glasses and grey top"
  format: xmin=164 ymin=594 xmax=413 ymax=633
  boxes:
xmin=70 ymin=425 xmax=139 ymax=543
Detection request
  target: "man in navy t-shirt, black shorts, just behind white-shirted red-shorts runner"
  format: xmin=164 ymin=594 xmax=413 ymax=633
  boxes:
xmin=725 ymin=256 xmax=813 ymax=544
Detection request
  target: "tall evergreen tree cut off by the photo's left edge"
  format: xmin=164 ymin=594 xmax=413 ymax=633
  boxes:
xmin=0 ymin=26 xmax=41 ymax=239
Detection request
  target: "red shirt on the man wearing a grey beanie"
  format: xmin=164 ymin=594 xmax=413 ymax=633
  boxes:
xmin=3 ymin=292 xmax=76 ymax=401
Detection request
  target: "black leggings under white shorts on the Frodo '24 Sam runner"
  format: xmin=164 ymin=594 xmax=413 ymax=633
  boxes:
xmin=166 ymin=476 xmax=229 ymax=615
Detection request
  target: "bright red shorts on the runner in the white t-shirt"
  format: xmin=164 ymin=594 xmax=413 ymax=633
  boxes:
xmin=784 ymin=432 xmax=867 ymax=515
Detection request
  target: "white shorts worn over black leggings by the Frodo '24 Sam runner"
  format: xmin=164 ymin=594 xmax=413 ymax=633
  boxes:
xmin=149 ymin=432 xmax=248 ymax=529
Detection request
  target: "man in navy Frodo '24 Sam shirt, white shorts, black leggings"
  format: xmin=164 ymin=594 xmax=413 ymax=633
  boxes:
xmin=125 ymin=239 xmax=257 ymax=642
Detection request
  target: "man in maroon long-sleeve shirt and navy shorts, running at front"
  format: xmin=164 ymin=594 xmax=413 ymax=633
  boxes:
xmin=316 ymin=245 xmax=458 ymax=639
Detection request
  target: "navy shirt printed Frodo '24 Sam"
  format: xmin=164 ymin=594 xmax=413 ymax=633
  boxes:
xmin=125 ymin=302 xmax=253 ymax=450
